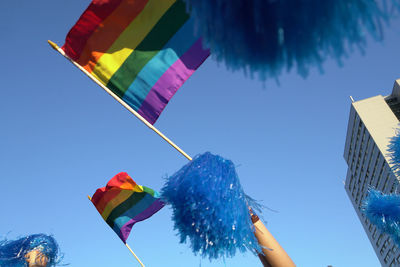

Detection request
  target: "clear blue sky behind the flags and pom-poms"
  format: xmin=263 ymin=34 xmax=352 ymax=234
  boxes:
xmin=0 ymin=0 xmax=400 ymax=267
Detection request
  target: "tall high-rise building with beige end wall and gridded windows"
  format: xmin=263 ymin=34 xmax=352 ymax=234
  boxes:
xmin=344 ymin=79 xmax=400 ymax=267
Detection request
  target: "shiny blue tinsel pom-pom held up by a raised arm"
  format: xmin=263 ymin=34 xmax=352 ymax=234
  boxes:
xmin=161 ymin=152 xmax=260 ymax=260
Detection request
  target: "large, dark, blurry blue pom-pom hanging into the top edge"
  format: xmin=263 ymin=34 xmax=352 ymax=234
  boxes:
xmin=184 ymin=0 xmax=399 ymax=79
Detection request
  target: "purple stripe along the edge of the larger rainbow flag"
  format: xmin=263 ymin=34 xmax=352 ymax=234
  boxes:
xmin=138 ymin=38 xmax=210 ymax=124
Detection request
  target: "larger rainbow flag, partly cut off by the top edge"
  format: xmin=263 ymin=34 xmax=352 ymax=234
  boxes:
xmin=62 ymin=0 xmax=209 ymax=124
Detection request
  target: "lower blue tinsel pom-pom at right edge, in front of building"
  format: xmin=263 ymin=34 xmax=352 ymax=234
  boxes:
xmin=362 ymin=189 xmax=400 ymax=246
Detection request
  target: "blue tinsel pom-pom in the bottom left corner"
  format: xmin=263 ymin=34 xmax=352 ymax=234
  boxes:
xmin=0 ymin=234 xmax=60 ymax=267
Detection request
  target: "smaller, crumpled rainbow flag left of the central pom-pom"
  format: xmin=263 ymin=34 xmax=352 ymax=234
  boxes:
xmin=91 ymin=172 xmax=165 ymax=243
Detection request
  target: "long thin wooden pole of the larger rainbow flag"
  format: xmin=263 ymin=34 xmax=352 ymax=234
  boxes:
xmin=47 ymin=40 xmax=192 ymax=160
